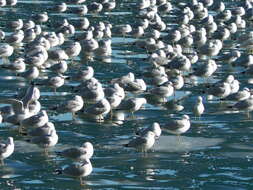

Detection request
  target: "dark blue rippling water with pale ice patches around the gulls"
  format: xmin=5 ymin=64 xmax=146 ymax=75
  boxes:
xmin=0 ymin=0 xmax=253 ymax=190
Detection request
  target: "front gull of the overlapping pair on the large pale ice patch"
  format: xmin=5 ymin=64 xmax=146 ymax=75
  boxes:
xmin=124 ymin=131 xmax=155 ymax=152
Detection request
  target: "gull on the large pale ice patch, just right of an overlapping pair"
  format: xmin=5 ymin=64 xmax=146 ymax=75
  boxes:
xmin=163 ymin=115 xmax=191 ymax=135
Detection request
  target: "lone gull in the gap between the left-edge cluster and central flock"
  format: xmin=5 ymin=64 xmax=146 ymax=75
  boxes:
xmin=53 ymin=95 xmax=84 ymax=118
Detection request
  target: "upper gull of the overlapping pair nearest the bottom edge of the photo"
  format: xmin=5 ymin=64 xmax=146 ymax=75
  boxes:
xmin=56 ymin=142 xmax=94 ymax=161
